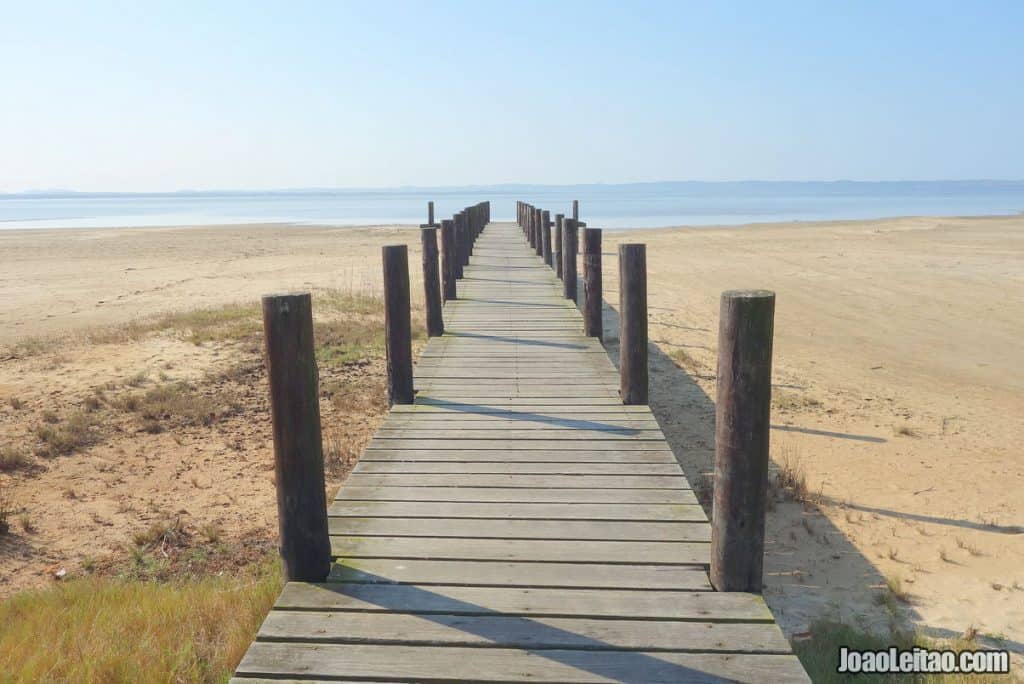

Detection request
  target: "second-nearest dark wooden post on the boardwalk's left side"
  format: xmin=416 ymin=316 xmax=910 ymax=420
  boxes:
xmin=383 ymin=245 xmax=415 ymax=403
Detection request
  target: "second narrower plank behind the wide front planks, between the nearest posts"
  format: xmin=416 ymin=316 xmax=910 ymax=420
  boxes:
xmin=331 ymin=537 xmax=711 ymax=565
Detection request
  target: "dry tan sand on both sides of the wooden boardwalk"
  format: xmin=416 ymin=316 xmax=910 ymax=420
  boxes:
xmin=0 ymin=217 xmax=1024 ymax=650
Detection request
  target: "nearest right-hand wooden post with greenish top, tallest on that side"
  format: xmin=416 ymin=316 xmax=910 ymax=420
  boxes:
xmin=710 ymin=290 xmax=775 ymax=593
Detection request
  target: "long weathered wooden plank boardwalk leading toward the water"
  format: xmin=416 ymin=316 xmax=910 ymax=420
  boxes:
xmin=232 ymin=223 xmax=809 ymax=684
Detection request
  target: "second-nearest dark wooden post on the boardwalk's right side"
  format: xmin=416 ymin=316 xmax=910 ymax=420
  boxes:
xmin=618 ymin=244 xmax=647 ymax=404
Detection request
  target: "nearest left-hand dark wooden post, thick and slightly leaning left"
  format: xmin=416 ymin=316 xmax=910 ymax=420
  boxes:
xmin=263 ymin=293 xmax=331 ymax=582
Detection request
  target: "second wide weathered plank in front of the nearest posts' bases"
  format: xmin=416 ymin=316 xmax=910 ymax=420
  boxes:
xmin=256 ymin=610 xmax=792 ymax=654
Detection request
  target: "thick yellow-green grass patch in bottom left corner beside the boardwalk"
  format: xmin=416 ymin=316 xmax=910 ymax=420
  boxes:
xmin=0 ymin=561 xmax=281 ymax=682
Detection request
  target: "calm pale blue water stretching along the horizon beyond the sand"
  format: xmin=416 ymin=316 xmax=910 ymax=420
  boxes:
xmin=0 ymin=181 xmax=1024 ymax=228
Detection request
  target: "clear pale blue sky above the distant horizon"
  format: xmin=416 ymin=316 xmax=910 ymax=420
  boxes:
xmin=0 ymin=0 xmax=1024 ymax=191
